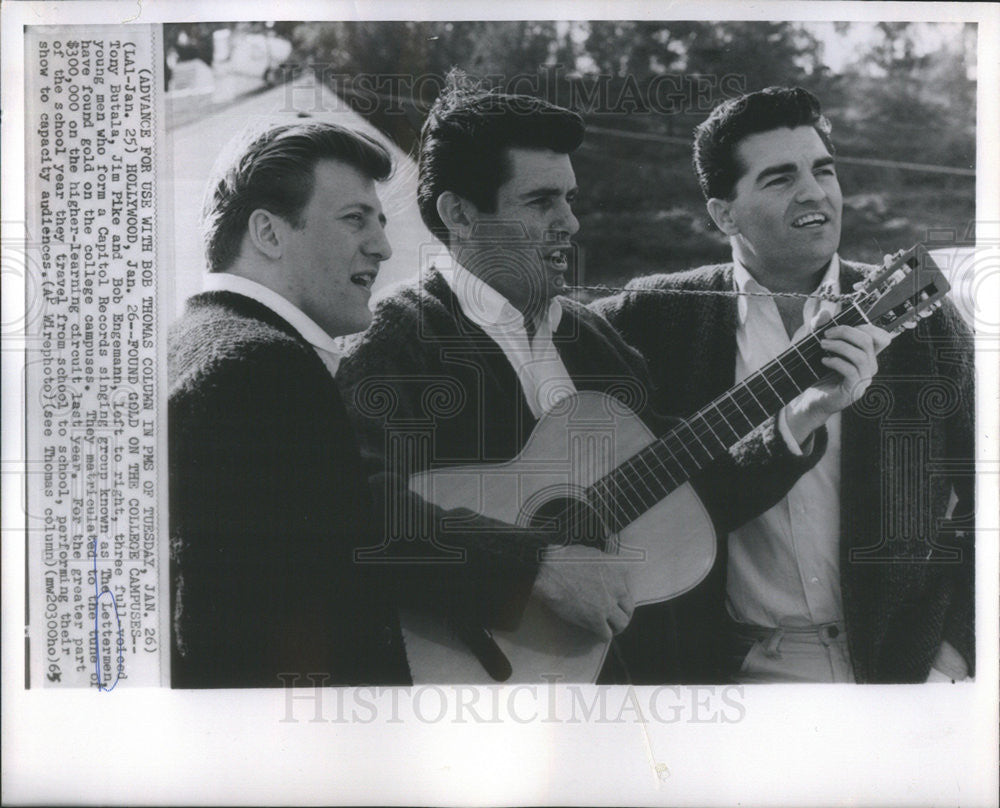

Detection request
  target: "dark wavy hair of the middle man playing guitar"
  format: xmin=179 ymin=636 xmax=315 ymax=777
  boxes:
xmin=417 ymin=70 xmax=584 ymax=244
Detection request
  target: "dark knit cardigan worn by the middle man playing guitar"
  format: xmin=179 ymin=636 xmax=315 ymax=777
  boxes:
xmin=337 ymin=270 xmax=826 ymax=682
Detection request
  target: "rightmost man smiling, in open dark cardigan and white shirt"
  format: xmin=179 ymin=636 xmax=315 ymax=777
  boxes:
xmin=594 ymin=87 xmax=975 ymax=683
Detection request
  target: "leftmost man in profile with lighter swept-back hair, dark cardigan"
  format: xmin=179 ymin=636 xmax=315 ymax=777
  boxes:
xmin=168 ymin=122 xmax=552 ymax=688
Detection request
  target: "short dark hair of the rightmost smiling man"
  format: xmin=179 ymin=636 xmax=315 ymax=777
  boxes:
xmin=694 ymin=87 xmax=834 ymax=199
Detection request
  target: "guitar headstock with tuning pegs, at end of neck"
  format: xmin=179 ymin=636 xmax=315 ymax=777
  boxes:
xmin=857 ymin=244 xmax=951 ymax=332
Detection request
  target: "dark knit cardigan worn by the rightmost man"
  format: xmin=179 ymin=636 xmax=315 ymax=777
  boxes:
xmin=594 ymin=261 xmax=975 ymax=683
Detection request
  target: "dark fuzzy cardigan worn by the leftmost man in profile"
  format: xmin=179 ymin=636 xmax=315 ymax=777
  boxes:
xmin=168 ymin=292 xmax=410 ymax=687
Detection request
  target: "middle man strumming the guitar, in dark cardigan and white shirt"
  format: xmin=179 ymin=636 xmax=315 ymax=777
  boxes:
xmin=338 ymin=71 xmax=884 ymax=682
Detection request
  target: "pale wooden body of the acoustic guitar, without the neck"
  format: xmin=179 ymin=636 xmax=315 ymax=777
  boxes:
xmin=400 ymin=391 xmax=716 ymax=684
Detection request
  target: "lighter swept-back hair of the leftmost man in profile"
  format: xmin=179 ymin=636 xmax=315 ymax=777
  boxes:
xmin=202 ymin=121 xmax=392 ymax=272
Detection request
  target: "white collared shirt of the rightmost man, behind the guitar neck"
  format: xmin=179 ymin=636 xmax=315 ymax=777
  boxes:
xmin=726 ymin=255 xmax=843 ymax=628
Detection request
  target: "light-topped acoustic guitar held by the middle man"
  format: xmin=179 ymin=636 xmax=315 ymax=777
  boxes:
xmin=400 ymin=244 xmax=950 ymax=684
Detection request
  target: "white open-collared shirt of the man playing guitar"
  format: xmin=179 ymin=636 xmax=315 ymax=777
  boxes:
xmin=441 ymin=263 xmax=576 ymax=418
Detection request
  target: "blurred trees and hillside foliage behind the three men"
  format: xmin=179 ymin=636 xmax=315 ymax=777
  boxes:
xmin=205 ymin=20 xmax=976 ymax=283
